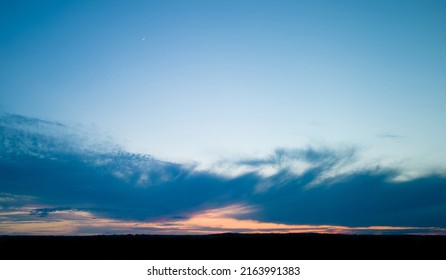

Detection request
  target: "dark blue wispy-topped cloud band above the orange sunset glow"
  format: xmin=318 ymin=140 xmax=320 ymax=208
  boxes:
xmin=0 ymin=115 xmax=446 ymax=232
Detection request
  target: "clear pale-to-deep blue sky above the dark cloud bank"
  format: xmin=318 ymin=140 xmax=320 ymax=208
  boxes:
xmin=0 ymin=1 xmax=446 ymax=234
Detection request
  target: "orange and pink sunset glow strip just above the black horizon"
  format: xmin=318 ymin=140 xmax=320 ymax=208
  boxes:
xmin=0 ymin=205 xmax=446 ymax=235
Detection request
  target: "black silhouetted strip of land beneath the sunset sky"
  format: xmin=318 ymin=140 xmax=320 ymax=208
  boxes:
xmin=0 ymin=234 xmax=446 ymax=260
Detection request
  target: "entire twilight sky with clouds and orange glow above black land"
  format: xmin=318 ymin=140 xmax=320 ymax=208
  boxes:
xmin=0 ymin=0 xmax=446 ymax=234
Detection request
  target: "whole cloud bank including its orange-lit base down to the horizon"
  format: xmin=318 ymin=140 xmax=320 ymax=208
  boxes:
xmin=0 ymin=116 xmax=446 ymax=234
